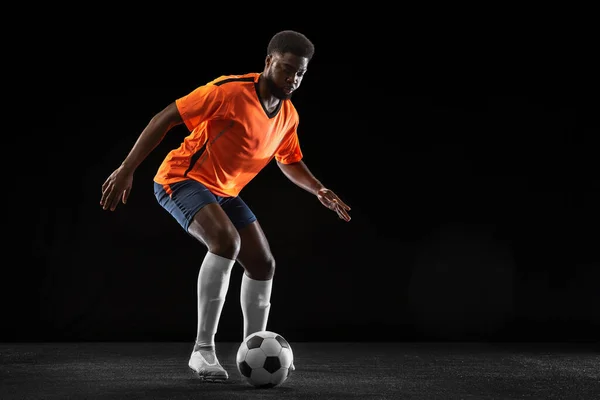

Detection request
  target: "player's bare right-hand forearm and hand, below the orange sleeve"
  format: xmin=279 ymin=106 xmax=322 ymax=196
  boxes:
xmin=277 ymin=160 xmax=350 ymax=222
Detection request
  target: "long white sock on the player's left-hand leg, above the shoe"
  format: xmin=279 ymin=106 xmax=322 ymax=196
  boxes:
xmin=194 ymin=252 xmax=235 ymax=352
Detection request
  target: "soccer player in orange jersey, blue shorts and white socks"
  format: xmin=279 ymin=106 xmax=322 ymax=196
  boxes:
xmin=100 ymin=30 xmax=350 ymax=381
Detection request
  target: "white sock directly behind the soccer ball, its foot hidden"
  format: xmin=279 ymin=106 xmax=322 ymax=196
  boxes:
xmin=240 ymin=273 xmax=273 ymax=340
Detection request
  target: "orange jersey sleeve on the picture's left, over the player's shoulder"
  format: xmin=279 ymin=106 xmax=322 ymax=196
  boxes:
xmin=175 ymin=84 xmax=228 ymax=131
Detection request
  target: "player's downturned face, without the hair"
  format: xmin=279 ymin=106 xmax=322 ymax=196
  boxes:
xmin=264 ymin=53 xmax=308 ymax=100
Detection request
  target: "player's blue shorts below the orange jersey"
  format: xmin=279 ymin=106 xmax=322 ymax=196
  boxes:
xmin=154 ymin=179 xmax=256 ymax=232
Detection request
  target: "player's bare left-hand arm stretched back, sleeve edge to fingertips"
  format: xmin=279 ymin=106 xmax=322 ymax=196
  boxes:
xmin=100 ymin=102 xmax=183 ymax=211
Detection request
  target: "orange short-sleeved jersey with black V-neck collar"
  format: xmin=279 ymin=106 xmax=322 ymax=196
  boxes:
xmin=154 ymin=73 xmax=302 ymax=197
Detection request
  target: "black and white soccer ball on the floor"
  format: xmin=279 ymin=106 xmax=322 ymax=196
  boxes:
xmin=236 ymin=331 xmax=294 ymax=388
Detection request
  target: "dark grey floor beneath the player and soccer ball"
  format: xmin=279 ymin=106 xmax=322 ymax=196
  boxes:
xmin=0 ymin=342 xmax=600 ymax=400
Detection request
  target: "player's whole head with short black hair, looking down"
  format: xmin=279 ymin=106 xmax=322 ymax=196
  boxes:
xmin=263 ymin=30 xmax=315 ymax=100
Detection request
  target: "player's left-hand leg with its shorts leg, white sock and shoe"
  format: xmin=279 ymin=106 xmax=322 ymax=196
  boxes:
xmin=155 ymin=180 xmax=240 ymax=381
